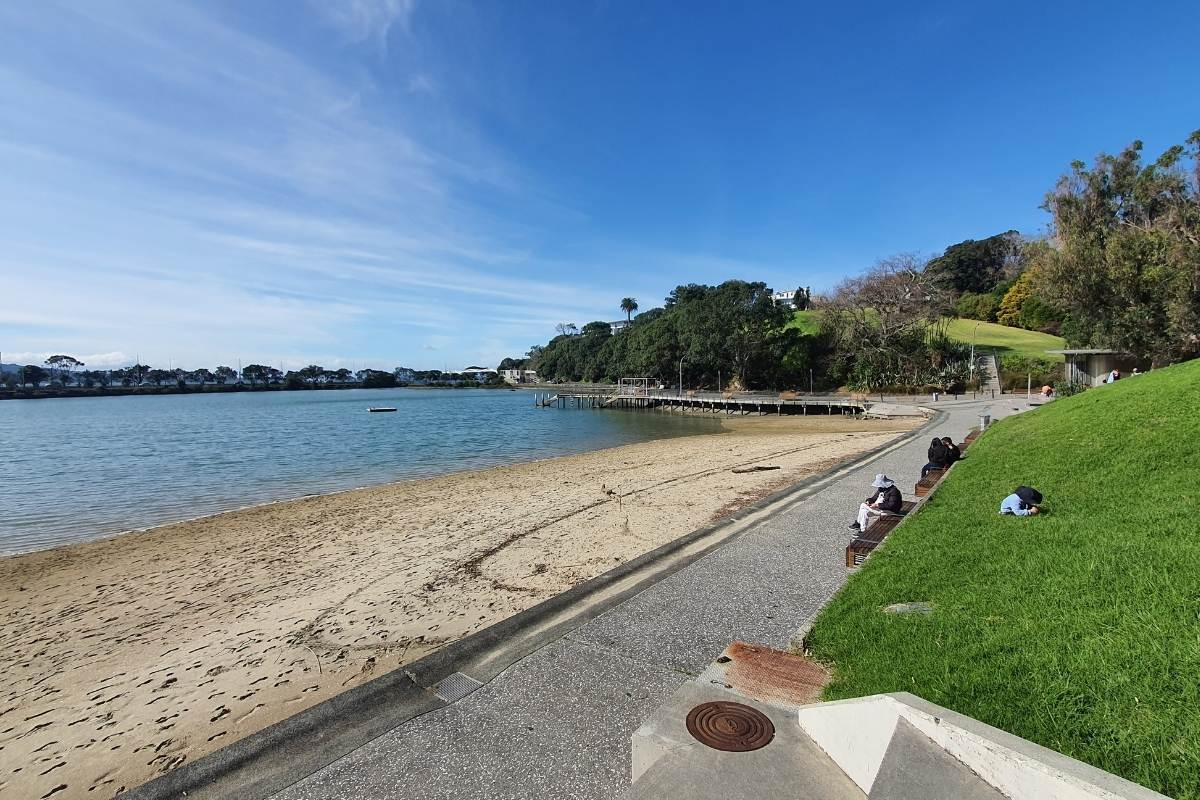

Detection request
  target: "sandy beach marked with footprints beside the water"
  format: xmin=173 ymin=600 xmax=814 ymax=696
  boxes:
xmin=0 ymin=416 xmax=914 ymax=800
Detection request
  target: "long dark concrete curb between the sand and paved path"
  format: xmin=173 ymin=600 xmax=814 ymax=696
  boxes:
xmin=122 ymin=411 xmax=946 ymax=800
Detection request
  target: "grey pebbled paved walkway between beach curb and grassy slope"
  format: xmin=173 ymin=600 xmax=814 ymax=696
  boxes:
xmin=275 ymin=398 xmax=1025 ymax=800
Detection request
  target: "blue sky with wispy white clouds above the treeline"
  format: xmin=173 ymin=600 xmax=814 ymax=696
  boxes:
xmin=0 ymin=0 xmax=1200 ymax=369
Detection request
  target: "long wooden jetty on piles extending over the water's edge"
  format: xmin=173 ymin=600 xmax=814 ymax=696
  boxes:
xmin=534 ymin=386 xmax=865 ymax=416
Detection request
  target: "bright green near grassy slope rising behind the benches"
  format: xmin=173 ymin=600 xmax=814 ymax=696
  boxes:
xmin=809 ymin=361 xmax=1200 ymax=800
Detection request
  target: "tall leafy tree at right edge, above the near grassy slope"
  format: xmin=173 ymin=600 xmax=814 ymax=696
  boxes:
xmin=1038 ymin=131 xmax=1200 ymax=361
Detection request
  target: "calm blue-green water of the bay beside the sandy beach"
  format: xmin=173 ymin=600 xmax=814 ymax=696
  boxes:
xmin=0 ymin=389 xmax=718 ymax=554
